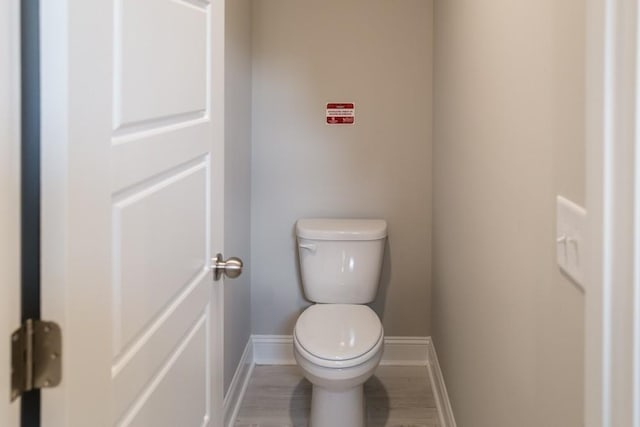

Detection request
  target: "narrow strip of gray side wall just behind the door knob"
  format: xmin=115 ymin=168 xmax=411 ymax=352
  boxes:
xmin=224 ymin=0 xmax=251 ymax=393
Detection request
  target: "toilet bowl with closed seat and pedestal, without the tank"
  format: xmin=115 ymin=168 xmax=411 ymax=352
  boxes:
xmin=293 ymin=304 xmax=384 ymax=427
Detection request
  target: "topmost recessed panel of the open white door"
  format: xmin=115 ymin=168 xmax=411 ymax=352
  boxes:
xmin=114 ymin=0 xmax=210 ymax=130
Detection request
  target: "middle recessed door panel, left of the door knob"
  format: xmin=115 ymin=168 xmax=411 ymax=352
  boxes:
xmin=113 ymin=159 xmax=209 ymax=354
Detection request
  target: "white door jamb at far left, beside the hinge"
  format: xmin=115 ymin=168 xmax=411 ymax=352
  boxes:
xmin=0 ymin=1 xmax=20 ymax=427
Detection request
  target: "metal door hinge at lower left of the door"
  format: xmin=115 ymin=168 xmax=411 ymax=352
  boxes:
xmin=11 ymin=319 xmax=62 ymax=401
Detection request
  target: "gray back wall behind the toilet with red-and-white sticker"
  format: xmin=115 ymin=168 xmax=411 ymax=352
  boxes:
xmin=251 ymin=0 xmax=433 ymax=336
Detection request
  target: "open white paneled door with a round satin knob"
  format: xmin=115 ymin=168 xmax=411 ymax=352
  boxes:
xmin=41 ymin=0 xmax=224 ymax=427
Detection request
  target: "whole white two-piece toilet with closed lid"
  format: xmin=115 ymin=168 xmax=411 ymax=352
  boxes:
xmin=293 ymin=219 xmax=387 ymax=427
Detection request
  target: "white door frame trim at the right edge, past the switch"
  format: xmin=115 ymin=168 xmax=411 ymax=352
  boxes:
xmin=584 ymin=0 xmax=640 ymax=427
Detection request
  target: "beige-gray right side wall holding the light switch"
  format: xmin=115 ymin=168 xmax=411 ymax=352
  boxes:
xmin=432 ymin=0 xmax=585 ymax=427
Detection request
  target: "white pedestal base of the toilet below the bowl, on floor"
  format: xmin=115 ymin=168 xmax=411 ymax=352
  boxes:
xmin=309 ymin=384 xmax=366 ymax=427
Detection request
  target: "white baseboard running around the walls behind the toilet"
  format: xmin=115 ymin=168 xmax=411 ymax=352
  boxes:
xmin=224 ymin=335 xmax=456 ymax=427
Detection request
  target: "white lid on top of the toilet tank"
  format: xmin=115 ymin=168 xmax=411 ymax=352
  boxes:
xmin=296 ymin=218 xmax=387 ymax=240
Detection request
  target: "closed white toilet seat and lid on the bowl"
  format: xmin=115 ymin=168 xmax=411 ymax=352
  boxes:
xmin=293 ymin=304 xmax=384 ymax=368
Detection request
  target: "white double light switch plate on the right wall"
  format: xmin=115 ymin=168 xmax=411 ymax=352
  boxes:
xmin=556 ymin=196 xmax=587 ymax=290
